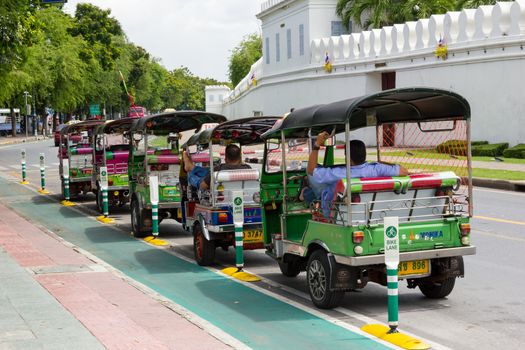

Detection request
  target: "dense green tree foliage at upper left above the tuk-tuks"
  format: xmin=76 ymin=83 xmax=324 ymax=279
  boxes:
xmin=0 ymin=0 xmax=229 ymax=123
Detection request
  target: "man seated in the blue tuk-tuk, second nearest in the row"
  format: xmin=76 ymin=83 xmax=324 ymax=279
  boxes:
xmin=182 ymin=145 xmax=251 ymax=190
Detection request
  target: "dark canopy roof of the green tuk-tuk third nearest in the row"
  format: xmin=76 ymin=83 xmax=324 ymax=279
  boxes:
xmin=132 ymin=111 xmax=226 ymax=135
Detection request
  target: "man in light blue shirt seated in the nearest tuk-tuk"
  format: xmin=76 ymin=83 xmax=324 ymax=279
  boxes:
xmin=306 ymin=131 xmax=408 ymax=216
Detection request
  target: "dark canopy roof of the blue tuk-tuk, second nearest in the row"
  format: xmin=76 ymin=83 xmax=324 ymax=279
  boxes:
xmin=183 ymin=116 xmax=280 ymax=147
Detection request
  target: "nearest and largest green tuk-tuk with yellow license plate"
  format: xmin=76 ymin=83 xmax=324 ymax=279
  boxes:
xmin=261 ymin=88 xmax=476 ymax=308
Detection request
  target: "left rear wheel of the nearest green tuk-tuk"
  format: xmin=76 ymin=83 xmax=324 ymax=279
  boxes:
xmin=306 ymin=249 xmax=345 ymax=309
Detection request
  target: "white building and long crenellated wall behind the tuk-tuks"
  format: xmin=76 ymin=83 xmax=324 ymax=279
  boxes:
xmin=206 ymin=0 xmax=525 ymax=145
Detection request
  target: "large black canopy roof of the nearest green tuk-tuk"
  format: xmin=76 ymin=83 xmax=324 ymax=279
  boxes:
xmin=263 ymin=87 xmax=470 ymax=138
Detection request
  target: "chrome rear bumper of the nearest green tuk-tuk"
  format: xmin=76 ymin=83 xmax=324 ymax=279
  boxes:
xmin=334 ymin=246 xmax=476 ymax=266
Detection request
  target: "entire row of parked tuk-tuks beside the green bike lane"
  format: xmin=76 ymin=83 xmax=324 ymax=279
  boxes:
xmin=58 ymin=88 xmax=475 ymax=308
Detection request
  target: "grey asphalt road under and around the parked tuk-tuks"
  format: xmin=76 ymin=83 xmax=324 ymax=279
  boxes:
xmin=0 ymin=140 xmax=525 ymax=349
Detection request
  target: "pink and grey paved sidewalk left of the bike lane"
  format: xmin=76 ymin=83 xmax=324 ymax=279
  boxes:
xmin=0 ymin=204 xmax=229 ymax=349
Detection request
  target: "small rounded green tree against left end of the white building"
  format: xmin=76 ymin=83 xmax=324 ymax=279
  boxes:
xmin=228 ymin=34 xmax=262 ymax=86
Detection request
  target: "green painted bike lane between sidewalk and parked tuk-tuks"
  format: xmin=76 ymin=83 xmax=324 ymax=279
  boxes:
xmin=0 ymin=178 xmax=388 ymax=349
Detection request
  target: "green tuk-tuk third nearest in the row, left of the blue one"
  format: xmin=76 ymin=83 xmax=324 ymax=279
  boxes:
xmin=128 ymin=111 xmax=226 ymax=237
